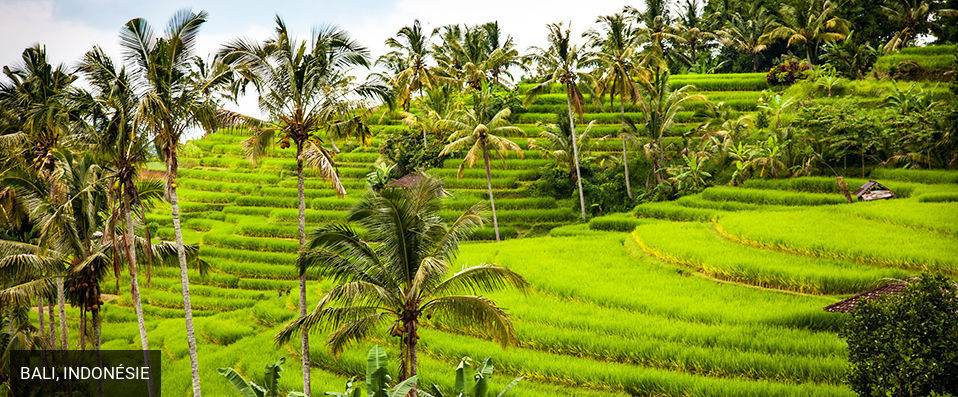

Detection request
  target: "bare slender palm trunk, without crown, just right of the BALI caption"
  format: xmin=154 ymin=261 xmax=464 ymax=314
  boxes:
xmin=166 ymin=152 xmax=202 ymax=397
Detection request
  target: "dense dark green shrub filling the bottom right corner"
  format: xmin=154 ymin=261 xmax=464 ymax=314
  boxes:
xmin=842 ymin=275 xmax=958 ymax=396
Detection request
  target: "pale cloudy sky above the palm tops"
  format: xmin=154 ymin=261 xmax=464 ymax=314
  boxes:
xmin=0 ymin=0 xmax=642 ymax=123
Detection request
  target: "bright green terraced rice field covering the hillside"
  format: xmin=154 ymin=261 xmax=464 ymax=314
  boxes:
xmin=73 ymin=75 xmax=958 ymax=396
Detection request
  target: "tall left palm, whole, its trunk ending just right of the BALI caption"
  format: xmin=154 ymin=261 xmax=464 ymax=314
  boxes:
xmin=120 ymin=10 xmax=230 ymax=397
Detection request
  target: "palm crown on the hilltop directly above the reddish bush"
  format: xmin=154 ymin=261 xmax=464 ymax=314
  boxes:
xmin=759 ymin=0 xmax=849 ymax=64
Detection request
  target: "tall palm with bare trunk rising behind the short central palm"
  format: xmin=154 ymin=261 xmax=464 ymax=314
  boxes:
xmin=218 ymin=16 xmax=385 ymax=396
